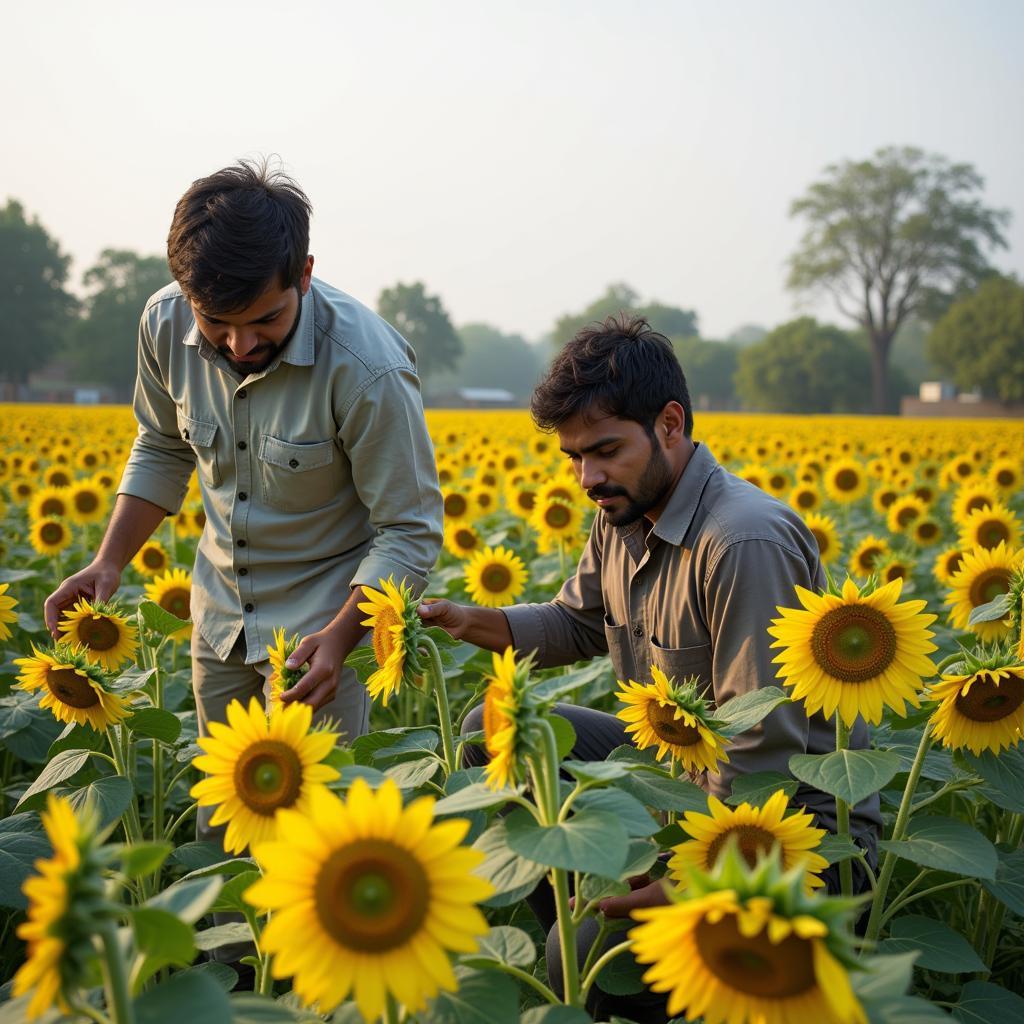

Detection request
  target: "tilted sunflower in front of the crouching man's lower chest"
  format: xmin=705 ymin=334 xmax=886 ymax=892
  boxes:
xmin=615 ymin=665 xmax=729 ymax=772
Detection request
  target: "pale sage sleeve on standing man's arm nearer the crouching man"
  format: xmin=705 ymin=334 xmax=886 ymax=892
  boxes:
xmin=338 ymin=367 xmax=442 ymax=597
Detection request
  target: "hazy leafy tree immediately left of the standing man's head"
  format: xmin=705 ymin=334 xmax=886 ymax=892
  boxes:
xmin=68 ymin=249 xmax=171 ymax=397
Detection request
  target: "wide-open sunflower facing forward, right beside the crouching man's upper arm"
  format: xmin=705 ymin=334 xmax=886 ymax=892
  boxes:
xmin=768 ymin=578 xmax=936 ymax=726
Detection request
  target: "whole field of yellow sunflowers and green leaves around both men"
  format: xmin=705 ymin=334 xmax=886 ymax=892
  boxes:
xmin=0 ymin=406 xmax=1024 ymax=1024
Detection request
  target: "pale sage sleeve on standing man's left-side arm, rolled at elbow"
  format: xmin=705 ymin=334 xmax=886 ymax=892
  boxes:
xmin=118 ymin=308 xmax=196 ymax=514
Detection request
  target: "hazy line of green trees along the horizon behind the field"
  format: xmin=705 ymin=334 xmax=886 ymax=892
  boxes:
xmin=0 ymin=147 xmax=1024 ymax=413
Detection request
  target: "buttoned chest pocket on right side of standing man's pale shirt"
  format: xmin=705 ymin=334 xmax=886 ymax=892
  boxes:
xmin=259 ymin=434 xmax=341 ymax=512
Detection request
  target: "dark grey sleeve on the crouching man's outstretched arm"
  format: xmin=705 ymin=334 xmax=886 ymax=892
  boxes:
xmin=502 ymin=517 xmax=608 ymax=669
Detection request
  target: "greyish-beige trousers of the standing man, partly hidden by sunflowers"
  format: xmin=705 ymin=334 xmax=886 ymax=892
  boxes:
xmin=191 ymin=629 xmax=370 ymax=962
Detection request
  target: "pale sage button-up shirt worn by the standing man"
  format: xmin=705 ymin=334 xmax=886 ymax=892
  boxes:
xmin=118 ymin=280 xmax=441 ymax=663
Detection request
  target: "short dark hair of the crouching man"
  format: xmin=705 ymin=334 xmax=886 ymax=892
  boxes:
xmin=529 ymin=312 xmax=693 ymax=437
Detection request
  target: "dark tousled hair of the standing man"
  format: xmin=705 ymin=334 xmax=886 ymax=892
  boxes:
xmin=167 ymin=160 xmax=312 ymax=314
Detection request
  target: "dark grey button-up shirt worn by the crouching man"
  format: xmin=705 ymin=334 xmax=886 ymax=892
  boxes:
xmin=503 ymin=444 xmax=881 ymax=846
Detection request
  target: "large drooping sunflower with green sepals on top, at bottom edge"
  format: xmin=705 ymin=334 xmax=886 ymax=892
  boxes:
xmin=629 ymin=843 xmax=866 ymax=1024
